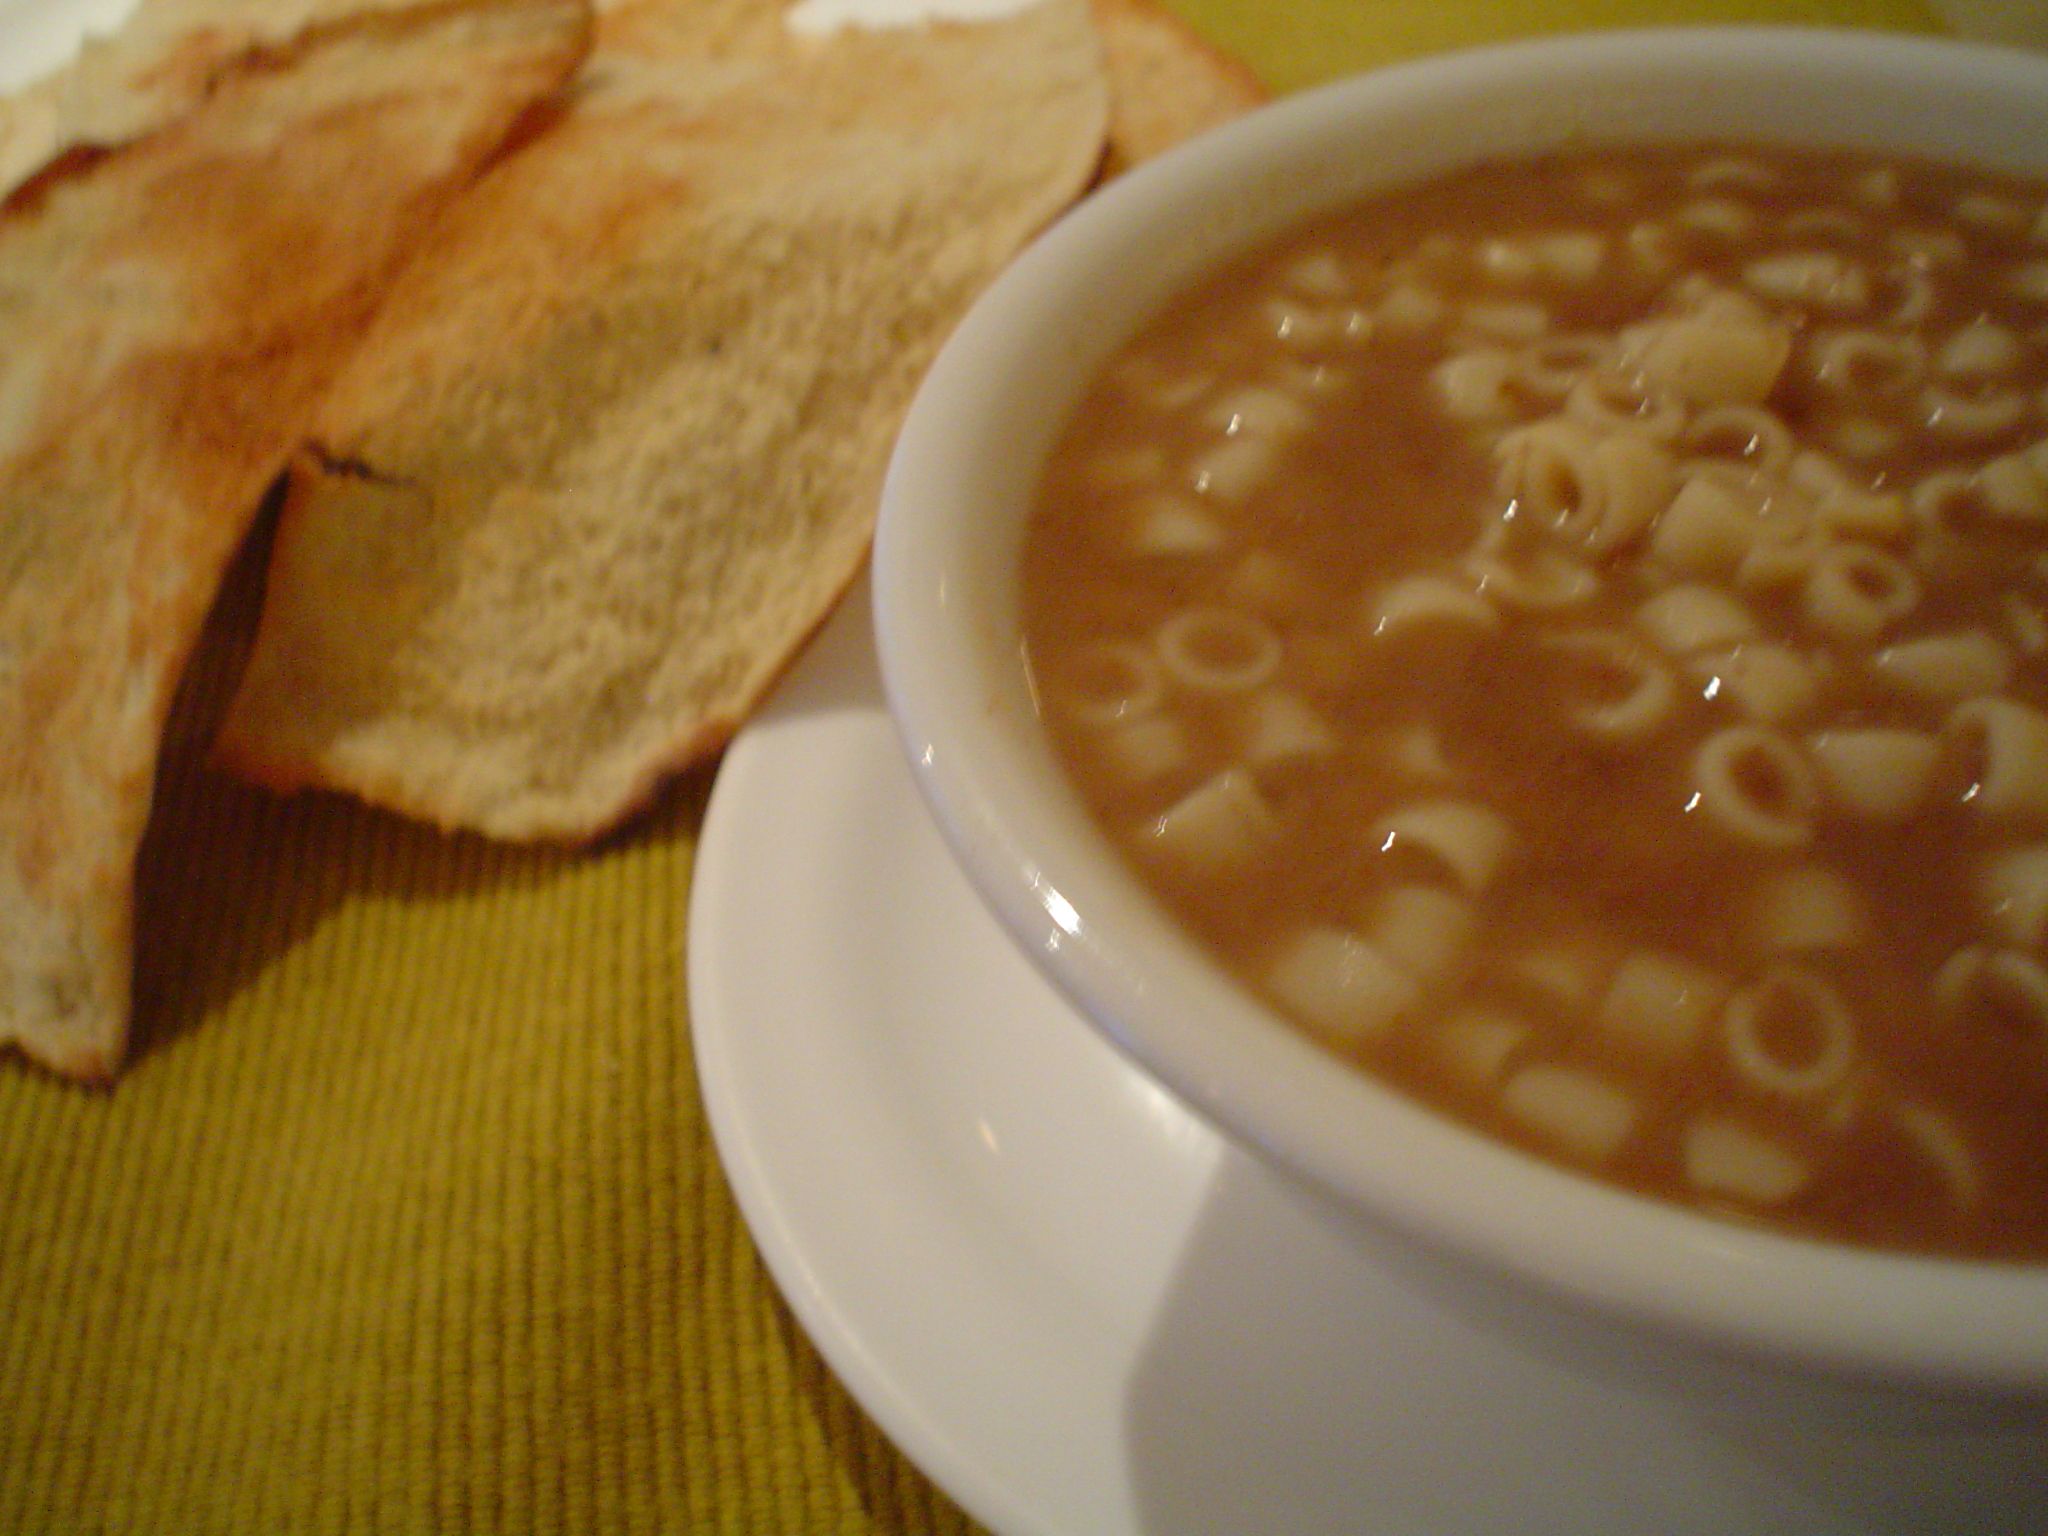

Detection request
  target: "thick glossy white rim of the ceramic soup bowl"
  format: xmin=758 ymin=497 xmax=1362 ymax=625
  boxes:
xmin=874 ymin=29 xmax=2048 ymax=1401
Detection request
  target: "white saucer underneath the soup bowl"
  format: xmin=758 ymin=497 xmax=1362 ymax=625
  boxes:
xmin=688 ymin=586 xmax=2048 ymax=1536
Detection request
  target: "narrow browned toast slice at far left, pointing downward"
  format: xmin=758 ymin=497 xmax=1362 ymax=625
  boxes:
xmin=0 ymin=0 xmax=590 ymax=1079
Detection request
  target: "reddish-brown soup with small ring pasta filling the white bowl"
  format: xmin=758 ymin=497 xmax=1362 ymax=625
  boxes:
xmin=1024 ymin=145 xmax=2048 ymax=1262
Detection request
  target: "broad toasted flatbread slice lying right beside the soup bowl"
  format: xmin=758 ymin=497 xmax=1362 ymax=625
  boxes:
xmin=217 ymin=0 xmax=1108 ymax=842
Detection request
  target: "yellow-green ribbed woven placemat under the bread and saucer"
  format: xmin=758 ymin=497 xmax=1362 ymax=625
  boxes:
xmin=0 ymin=0 xmax=1931 ymax=1532
